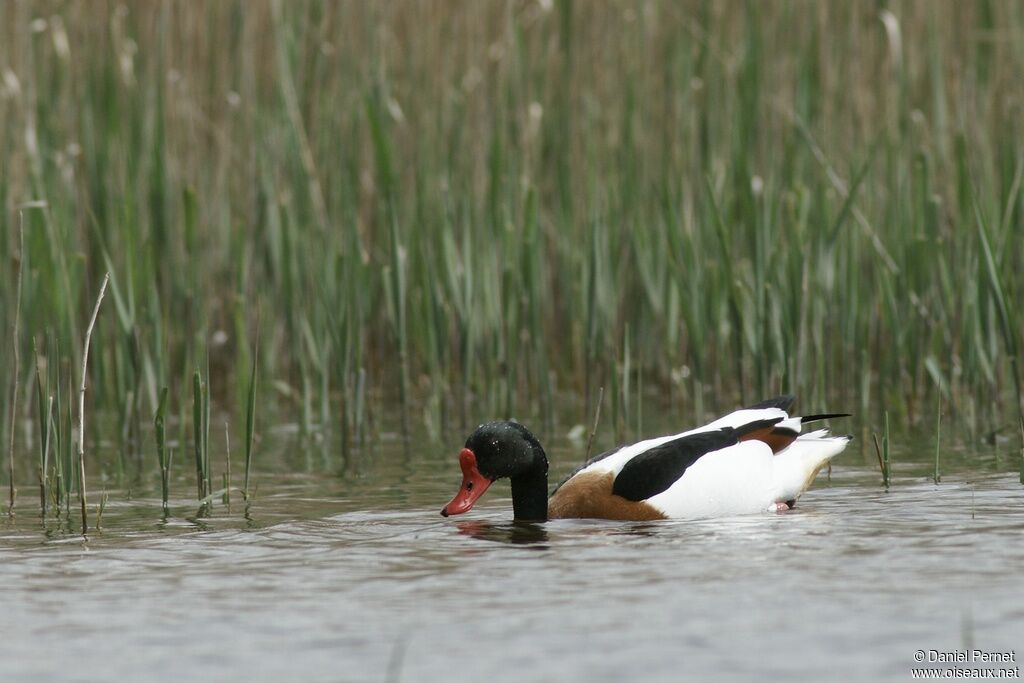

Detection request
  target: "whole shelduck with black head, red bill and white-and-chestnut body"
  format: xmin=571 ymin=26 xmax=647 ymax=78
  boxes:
xmin=441 ymin=395 xmax=852 ymax=521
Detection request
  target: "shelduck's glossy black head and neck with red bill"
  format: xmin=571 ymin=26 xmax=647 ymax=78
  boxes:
xmin=441 ymin=422 xmax=548 ymax=520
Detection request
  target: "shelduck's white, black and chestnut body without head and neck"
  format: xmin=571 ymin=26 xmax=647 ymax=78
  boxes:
xmin=549 ymin=395 xmax=849 ymax=519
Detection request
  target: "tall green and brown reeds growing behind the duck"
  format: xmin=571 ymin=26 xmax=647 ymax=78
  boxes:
xmin=0 ymin=0 xmax=1024 ymax=508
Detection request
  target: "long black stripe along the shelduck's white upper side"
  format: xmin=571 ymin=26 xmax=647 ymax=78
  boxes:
xmin=611 ymin=418 xmax=782 ymax=501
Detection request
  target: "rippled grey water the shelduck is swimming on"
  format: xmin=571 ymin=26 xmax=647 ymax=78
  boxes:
xmin=0 ymin=436 xmax=1024 ymax=682
